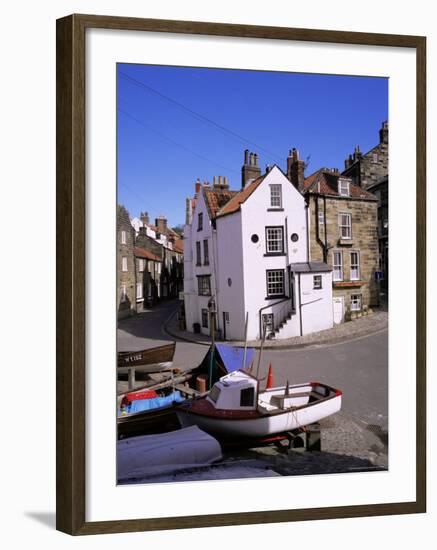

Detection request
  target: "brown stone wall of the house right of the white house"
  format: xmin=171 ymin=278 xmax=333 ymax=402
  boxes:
xmin=309 ymin=194 xmax=379 ymax=319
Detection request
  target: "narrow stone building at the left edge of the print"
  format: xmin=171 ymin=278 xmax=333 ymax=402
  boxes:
xmin=117 ymin=205 xmax=136 ymax=319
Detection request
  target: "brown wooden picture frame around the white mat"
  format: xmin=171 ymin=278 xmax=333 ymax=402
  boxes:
xmin=56 ymin=15 xmax=426 ymax=535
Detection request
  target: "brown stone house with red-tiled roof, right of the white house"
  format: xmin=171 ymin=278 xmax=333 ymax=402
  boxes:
xmin=289 ymin=164 xmax=379 ymax=323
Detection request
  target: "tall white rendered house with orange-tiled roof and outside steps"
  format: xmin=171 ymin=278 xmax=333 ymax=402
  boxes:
xmin=184 ymin=166 xmax=333 ymax=340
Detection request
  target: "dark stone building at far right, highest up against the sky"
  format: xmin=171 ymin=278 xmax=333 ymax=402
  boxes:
xmin=342 ymin=121 xmax=388 ymax=189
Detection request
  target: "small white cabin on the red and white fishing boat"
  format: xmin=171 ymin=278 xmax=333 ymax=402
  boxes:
xmin=206 ymin=371 xmax=258 ymax=411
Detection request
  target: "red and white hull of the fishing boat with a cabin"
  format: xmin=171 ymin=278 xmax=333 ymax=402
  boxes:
xmin=177 ymin=386 xmax=342 ymax=438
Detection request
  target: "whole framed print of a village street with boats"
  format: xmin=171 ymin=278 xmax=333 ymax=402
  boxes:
xmin=57 ymin=15 xmax=426 ymax=535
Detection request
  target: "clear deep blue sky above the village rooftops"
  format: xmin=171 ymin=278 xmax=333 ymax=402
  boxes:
xmin=117 ymin=64 xmax=388 ymax=226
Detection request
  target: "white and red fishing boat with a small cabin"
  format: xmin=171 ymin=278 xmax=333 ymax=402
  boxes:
xmin=176 ymin=371 xmax=342 ymax=437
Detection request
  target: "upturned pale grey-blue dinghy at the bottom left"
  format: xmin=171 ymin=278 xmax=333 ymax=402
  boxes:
xmin=117 ymin=426 xmax=222 ymax=483
